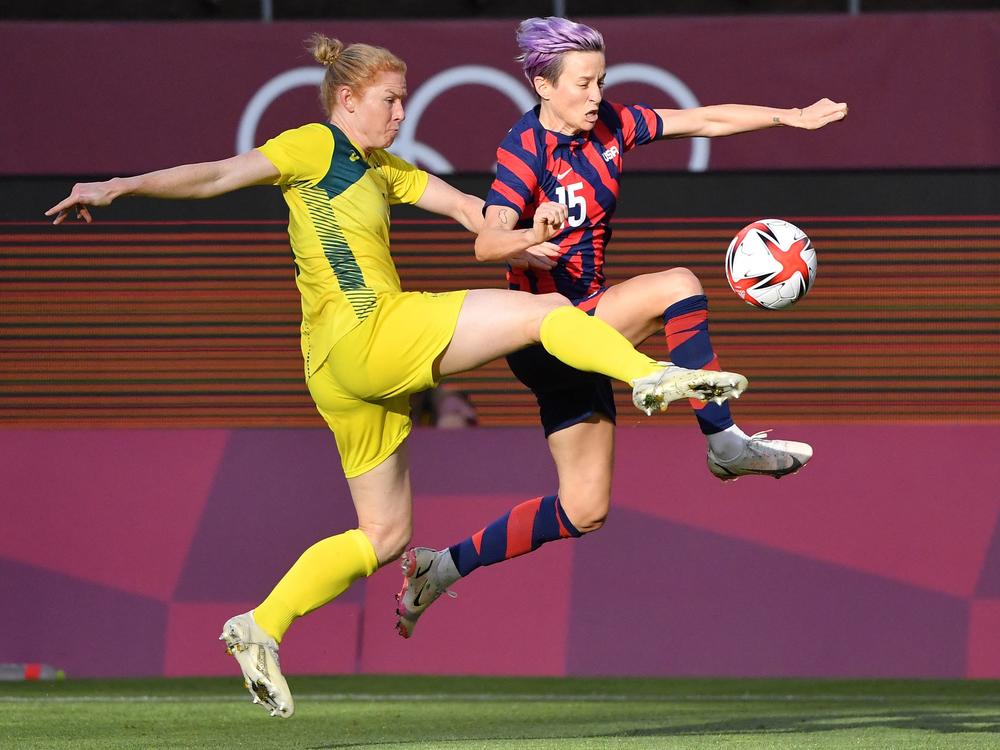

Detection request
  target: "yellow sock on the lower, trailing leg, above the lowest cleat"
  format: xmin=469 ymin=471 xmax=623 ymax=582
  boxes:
xmin=253 ymin=529 xmax=378 ymax=643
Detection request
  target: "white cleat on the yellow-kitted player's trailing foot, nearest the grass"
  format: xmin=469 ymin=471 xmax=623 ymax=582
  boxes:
xmin=219 ymin=610 xmax=295 ymax=719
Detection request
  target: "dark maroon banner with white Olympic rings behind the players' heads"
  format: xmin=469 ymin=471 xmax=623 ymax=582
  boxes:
xmin=0 ymin=12 xmax=1000 ymax=174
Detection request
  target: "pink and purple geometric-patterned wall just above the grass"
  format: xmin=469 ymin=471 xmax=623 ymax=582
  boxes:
xmin=0 ymin=420 xmax=1000 ymax=677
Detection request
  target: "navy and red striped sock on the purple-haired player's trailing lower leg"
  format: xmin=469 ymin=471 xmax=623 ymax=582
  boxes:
xmin=449 ymin=495 xmax=581 ymax=576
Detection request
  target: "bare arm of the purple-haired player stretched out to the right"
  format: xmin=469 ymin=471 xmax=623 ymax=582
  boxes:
xmin=656 ymin=99 xmax=847 ymax=138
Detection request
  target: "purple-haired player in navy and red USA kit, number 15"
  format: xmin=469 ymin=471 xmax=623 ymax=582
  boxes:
xmin=396 ymin=17 xmax=847 ymax=638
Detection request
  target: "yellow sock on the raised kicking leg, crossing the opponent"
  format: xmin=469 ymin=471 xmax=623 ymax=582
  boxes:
xmin=540 ymin=305 xmax=660 ymax=384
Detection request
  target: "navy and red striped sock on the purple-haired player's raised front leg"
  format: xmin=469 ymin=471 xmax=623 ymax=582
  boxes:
xmin=663 ymin=294 xmax=733 ymax=435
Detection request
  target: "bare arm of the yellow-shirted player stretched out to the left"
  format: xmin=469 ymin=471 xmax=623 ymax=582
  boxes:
xmin=45 ymin=149 xmax=279 ymax=224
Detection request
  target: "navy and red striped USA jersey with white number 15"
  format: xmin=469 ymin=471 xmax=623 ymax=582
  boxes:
xmin=486 ymin=101 xmax=663 ymax=301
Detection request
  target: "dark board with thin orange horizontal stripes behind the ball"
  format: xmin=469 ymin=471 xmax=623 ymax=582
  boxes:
xmin=0 ymin=215 xmax=1000 ymax=428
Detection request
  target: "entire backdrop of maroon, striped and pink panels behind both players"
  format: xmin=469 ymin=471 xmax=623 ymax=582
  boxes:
xmin=0 ymin=2 xmax=1000 ymax=677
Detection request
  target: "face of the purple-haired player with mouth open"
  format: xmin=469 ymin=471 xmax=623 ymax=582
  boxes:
xmin=540 ymin=52 xmax=604 ymax=135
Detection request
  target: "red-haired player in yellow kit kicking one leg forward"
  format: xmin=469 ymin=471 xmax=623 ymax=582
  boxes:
xmin=46 ymin=35 xmax=746 ymax=717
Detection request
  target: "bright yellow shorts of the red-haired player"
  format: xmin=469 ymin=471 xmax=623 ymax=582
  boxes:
xmin=308 ymin=291 xmax=466 ymax=478
